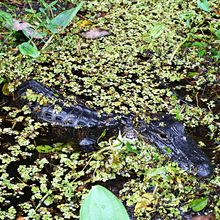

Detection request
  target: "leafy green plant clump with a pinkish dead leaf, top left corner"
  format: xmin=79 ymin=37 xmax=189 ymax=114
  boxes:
xmin=0 ymin=0 xmax=83 ymax=58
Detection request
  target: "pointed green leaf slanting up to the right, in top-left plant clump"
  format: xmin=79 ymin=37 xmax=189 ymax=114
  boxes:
xmin=51 ymin=2 xmax=83 ymax=32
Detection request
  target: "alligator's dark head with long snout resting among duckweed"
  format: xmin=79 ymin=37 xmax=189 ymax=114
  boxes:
xmin=137 ymin=117 xmax=213 ymax=177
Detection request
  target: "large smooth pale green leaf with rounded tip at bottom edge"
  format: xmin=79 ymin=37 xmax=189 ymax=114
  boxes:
xmin=80 ymin=185 xmax=129 ymax=220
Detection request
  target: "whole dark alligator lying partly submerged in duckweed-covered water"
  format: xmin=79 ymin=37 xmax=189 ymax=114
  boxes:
xmin=14 ymin=79 xmax=213 ymax=177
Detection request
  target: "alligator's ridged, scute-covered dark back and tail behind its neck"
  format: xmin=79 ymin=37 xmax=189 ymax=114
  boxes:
xmin=16 ymin=80 xmax=118 ymax=128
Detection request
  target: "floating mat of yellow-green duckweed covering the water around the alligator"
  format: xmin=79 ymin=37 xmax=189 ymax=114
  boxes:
xmin=0 ymin=0 xmax=220 ymax=220
